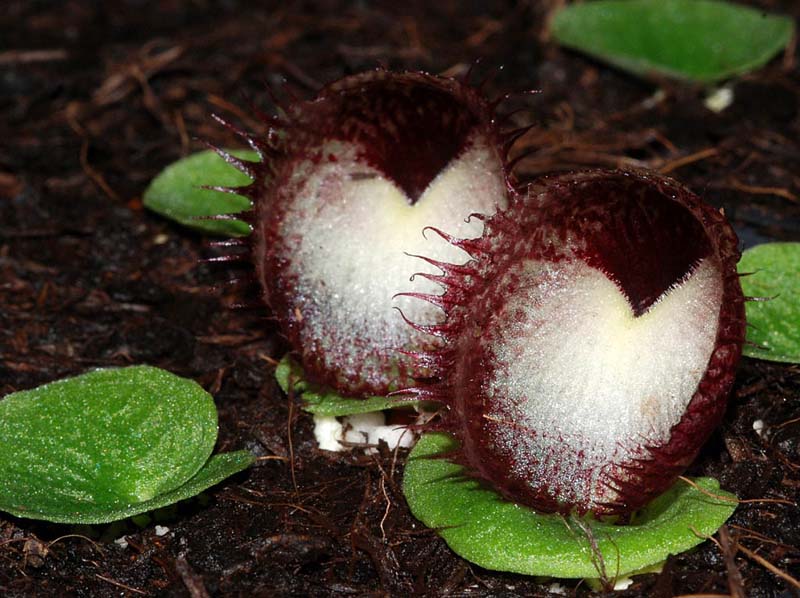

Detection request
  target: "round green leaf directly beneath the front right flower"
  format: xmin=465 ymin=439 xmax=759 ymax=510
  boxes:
xmin=403 ymin=434 xmax=736 ymax=578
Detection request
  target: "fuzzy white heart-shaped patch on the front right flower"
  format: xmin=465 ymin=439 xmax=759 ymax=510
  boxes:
xmin=489 ymin=259 xmax=722 ymax=504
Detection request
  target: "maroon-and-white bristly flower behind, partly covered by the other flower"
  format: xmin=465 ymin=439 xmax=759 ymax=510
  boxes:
xmin=209 ymin=70 xmax=526 ymax=396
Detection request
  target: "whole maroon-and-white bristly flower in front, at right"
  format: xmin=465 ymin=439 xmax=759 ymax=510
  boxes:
xmin=407 ymin=171 xmax=745 ymax=516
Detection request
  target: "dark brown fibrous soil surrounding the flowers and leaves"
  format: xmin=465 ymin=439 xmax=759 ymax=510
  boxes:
xmin=0 ymin=0 xmax=800 ymax=597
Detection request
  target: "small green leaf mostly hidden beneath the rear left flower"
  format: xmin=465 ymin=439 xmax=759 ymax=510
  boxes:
xmin=275 ymin=354 xmax=414 ymax=417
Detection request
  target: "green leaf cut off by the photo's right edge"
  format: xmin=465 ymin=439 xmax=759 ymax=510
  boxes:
xmin=739 ymin=243 xmax=800 ymax=363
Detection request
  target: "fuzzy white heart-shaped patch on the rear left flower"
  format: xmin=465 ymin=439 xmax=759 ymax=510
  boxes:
xmin=284 ymin=137 xmax=506 ymax=384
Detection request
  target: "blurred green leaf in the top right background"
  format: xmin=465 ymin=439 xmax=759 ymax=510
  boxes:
xmin=552 ymin=0 xmax=794 ymax=83
